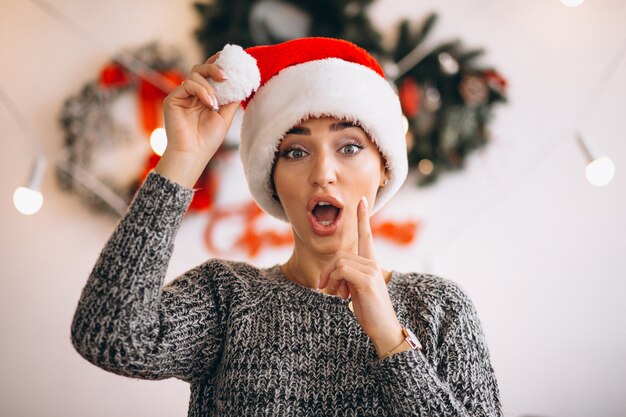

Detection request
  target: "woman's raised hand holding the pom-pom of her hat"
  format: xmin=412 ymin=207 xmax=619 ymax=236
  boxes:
xmin=155 ymin=52 xmax=239 ymax=188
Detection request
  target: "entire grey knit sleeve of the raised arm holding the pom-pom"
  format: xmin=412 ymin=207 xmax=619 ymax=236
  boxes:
xmin=71 ymin=170 xmax=221 ymax=382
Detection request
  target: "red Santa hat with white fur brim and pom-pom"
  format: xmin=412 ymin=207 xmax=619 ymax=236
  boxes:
xmin=209 ymin=37 xmax=408 ymax=220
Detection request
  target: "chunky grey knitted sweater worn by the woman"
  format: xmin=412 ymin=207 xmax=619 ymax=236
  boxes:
xmin=71 ymin=171 xmax=502 ymax=417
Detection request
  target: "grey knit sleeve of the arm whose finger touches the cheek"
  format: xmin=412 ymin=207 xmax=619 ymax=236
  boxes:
xmin=372 ymin=281 xmax=502 ymax=417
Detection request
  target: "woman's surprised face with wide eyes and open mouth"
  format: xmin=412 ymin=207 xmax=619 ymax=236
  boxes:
xmin=274 ymin=117 xmax=386 ymax=254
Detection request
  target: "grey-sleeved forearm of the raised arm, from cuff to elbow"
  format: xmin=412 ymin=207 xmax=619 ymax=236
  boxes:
xmin=71 ymin=169 xmax=193 ymax=375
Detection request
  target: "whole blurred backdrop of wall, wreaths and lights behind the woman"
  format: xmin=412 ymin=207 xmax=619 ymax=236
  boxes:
xmin=0 ymin=0 xmax=626 ymax=417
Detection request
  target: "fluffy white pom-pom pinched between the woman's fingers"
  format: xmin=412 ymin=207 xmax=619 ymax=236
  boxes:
xmin=207 ymin=44 xmax=261 ymax=106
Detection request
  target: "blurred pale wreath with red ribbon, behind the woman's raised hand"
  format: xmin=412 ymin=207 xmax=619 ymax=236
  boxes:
xmin=56 ymin=43 xmax=216 ymax=215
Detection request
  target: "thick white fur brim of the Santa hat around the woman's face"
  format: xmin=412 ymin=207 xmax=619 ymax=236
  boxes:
xmin=240 ymin=58 xmax=408 ymax=221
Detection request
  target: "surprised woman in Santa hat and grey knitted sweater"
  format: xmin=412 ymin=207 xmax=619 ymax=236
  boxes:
xmin=72 ymin=38 xmax=502 ymax=416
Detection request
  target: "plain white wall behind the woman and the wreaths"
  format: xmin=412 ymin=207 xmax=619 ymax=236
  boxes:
xmin=0 ymin=0 xmax=626 ymax=417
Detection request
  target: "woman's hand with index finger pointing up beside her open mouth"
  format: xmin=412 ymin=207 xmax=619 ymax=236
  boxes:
xmin=319 ymin=197 xmax=403 ymax=356
